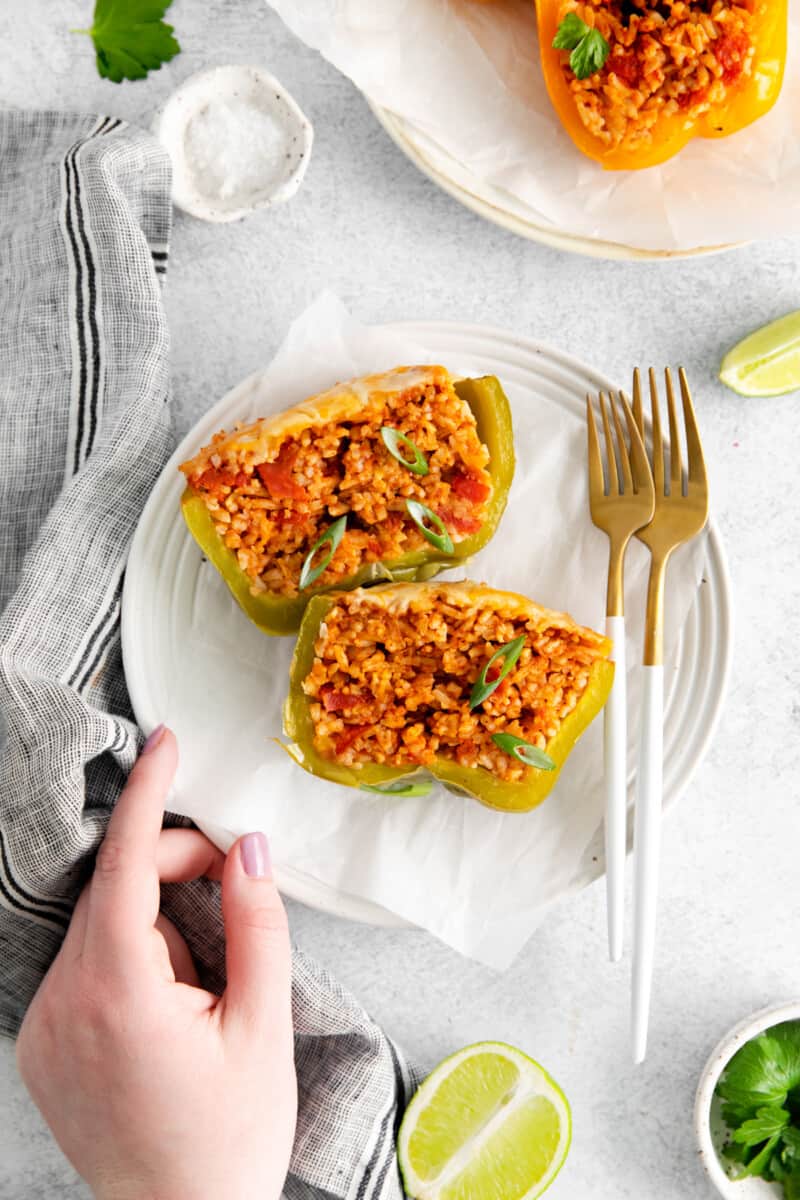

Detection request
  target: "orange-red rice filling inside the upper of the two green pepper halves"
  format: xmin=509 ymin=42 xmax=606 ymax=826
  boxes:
xmin=183 ymin=378 xmax=492 ymax=596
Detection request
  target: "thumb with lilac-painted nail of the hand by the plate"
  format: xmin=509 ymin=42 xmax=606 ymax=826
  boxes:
xmin=222 ymin=833 xmax=291 ymax=1034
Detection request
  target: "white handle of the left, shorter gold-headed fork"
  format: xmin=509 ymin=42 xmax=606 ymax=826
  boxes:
xmin=603 ymin=617 xmax=627 ymax=962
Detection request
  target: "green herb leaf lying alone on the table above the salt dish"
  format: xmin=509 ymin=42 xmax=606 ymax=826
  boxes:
xmin=77 ymin=0 xmax=180 ymax=83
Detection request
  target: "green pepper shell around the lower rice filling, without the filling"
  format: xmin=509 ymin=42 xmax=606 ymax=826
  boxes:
xmin=283 ymin=594 xmax=614 ymax=812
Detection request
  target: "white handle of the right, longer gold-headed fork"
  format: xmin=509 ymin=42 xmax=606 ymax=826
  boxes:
xmin=631 ymin=666 xmax=663 ymax=1062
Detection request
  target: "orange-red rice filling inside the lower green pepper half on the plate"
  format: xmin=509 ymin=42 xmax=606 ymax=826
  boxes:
xmin=303 ymin=589 xmax=604 ymax=782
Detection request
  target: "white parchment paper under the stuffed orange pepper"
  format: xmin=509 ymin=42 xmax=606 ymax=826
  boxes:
xmin=263 ymin=0 xmax=800 ymax=250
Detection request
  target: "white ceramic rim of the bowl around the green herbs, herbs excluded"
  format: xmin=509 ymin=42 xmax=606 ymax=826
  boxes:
xmin=694 ymin=1000 xmax=800 ymax=1200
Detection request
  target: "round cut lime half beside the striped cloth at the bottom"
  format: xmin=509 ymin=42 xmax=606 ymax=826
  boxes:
xmin=397 ymin=1042 xmax=572 ymax=1200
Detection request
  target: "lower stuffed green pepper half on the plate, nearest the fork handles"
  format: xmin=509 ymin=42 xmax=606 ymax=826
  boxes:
xmin=284 ymin=582 xmax=614 ymax=812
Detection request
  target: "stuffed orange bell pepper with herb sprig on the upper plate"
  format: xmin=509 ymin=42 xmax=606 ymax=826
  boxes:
xmin=536 ymin=0 xmax=788 ymax=170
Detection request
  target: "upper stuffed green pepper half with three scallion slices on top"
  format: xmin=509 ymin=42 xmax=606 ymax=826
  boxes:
xmin=181 ymin=366 xmax=515 ymax=634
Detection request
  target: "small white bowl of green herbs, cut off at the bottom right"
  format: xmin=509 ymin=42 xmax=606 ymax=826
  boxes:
xmin=694 ymin=1001 xmax=800 ymax=1200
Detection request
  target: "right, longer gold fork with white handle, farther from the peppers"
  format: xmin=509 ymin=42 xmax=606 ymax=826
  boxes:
xmin=631 ymin=367 xmax=709 ymax=1062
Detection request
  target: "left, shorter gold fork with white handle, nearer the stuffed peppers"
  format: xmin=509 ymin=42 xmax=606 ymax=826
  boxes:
xmin=587 ymin=391 xmax=655 ymax=962
